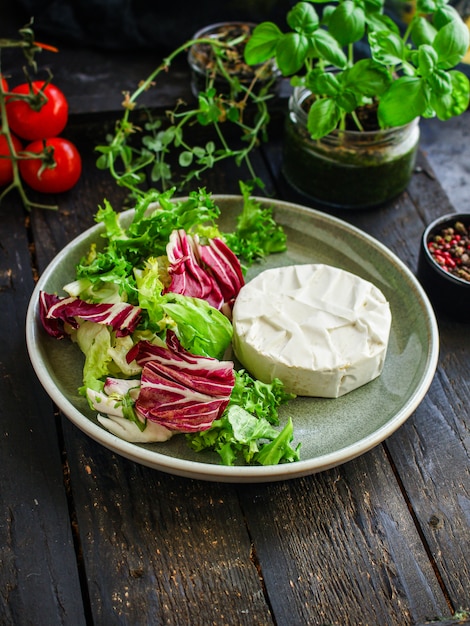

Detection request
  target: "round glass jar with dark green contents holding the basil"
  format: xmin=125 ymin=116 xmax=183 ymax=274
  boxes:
xmin=282 ymin=87 xmax=419 ymax=209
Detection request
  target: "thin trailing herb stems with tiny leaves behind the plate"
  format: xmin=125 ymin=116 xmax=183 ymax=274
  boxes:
xmin=96 ymin=26 xmax=276 ymax=199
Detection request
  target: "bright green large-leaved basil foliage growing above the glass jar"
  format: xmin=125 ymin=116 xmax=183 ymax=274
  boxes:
xmin=245 ymin=0 xmax=470 ymax=139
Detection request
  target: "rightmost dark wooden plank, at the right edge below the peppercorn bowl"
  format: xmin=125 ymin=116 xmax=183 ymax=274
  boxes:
xmin=387 ymin=320 xmax=470 ymax=610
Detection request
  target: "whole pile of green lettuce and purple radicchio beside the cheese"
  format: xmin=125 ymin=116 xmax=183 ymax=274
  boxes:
xmin=40 ymin=183 xmax=299 ymax=464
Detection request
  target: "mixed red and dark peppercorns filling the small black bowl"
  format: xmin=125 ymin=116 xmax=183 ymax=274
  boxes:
xmin=427 ymin=222 xmax=470 ymax=282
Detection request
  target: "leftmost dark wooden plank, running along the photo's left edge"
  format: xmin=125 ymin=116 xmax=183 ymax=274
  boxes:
xmin=0 ymin=196 xmax=85 ymax=626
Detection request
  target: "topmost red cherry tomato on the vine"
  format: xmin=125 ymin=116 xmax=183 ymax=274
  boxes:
xmin=7 ymin=80 xmax=69 ymax=141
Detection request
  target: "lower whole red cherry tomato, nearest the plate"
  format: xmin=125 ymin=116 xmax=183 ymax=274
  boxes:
xmin=18 ymin=137 xmax=82 ymax=193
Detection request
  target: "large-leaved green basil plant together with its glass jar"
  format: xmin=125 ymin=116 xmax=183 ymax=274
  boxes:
xmin=245 ymin=0 xmax=470 ymax=208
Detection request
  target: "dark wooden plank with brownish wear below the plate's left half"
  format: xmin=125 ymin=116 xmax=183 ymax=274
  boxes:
xmin=64 ymin=416 xmax=274 ymax=626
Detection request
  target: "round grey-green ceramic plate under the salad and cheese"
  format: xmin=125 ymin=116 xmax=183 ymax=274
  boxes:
xmin=26 ymin=196 xmax=439 ymax=482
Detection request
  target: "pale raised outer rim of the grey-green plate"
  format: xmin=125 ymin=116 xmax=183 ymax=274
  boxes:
xmin=26 ymin=194 xmax=439 ymax=483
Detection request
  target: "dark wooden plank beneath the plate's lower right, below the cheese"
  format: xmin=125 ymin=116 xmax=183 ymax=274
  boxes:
xmin=240 ymin=446 xmax=449 ymax=626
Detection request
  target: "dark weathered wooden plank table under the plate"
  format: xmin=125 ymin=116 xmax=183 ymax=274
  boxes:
xmin=0 ymin=36 xmax=470 ymax=626
